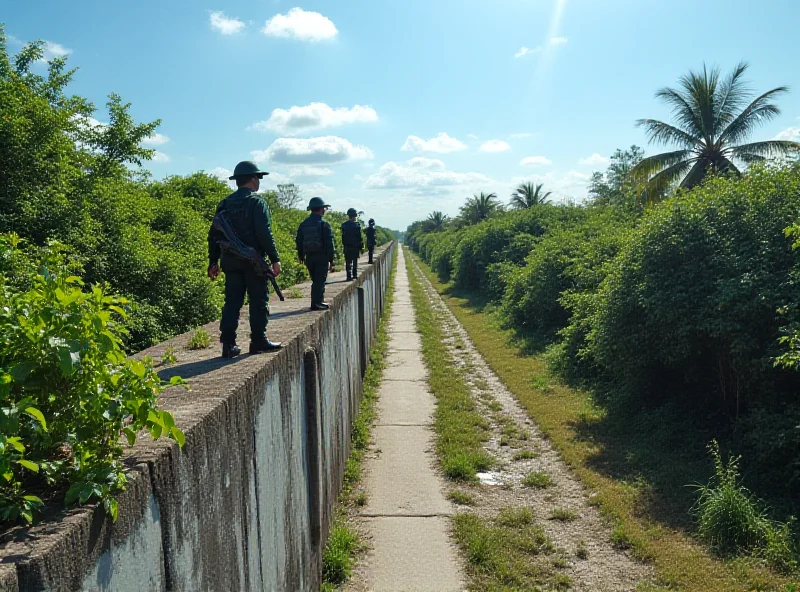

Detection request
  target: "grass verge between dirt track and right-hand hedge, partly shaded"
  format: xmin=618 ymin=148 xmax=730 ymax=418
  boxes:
xmin=410 ymin=252 xmax=798 ymax=592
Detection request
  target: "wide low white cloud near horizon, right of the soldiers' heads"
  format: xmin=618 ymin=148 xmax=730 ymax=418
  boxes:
xmin=364 ymin=157 xmax=492 ymax=192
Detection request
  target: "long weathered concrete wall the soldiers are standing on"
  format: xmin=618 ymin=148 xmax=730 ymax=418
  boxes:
xmin=0 ymin=245 xmax=394 ymax=592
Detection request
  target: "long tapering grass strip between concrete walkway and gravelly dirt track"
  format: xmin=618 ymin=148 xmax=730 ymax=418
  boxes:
xmin=406 ymin=250 xmax=493 ymax=482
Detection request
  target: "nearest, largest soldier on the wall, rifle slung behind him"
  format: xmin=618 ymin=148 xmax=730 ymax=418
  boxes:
xmin=208 ymin=161 xmax=281 ymax=358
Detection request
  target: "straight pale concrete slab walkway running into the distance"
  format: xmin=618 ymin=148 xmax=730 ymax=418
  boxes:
xmin=360 ymin=249 xmax=465 ymax=592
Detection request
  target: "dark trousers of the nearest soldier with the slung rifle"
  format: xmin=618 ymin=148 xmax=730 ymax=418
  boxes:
xmin=219 ymin=271 xmax=269 ymax=344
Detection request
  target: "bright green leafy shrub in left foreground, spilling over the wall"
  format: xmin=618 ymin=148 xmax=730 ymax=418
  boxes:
xmin=0 ymin=236 xmax=184 ymax=522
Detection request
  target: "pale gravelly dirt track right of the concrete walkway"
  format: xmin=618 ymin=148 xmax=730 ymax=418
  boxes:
xmin=410 ymin=252 xmax=652 ymax=592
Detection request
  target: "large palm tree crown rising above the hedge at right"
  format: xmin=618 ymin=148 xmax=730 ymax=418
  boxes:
xmin=631 ymin=62 xmax=800 ymax=201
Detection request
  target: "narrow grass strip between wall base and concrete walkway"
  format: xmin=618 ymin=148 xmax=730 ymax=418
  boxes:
xmin=322 ymin=252 xmax=397 ymax=592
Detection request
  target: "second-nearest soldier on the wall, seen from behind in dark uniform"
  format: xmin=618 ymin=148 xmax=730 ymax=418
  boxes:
xmin=295 ymin=197 xmax=336 ymax=310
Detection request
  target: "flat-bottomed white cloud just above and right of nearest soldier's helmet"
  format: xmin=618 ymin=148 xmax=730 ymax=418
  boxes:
xmin=250 ymin=136 xmax=372 ymax=165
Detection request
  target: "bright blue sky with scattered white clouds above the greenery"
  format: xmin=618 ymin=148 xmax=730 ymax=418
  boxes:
xmin=0 ymin=0 xmax=800 ymax=228
